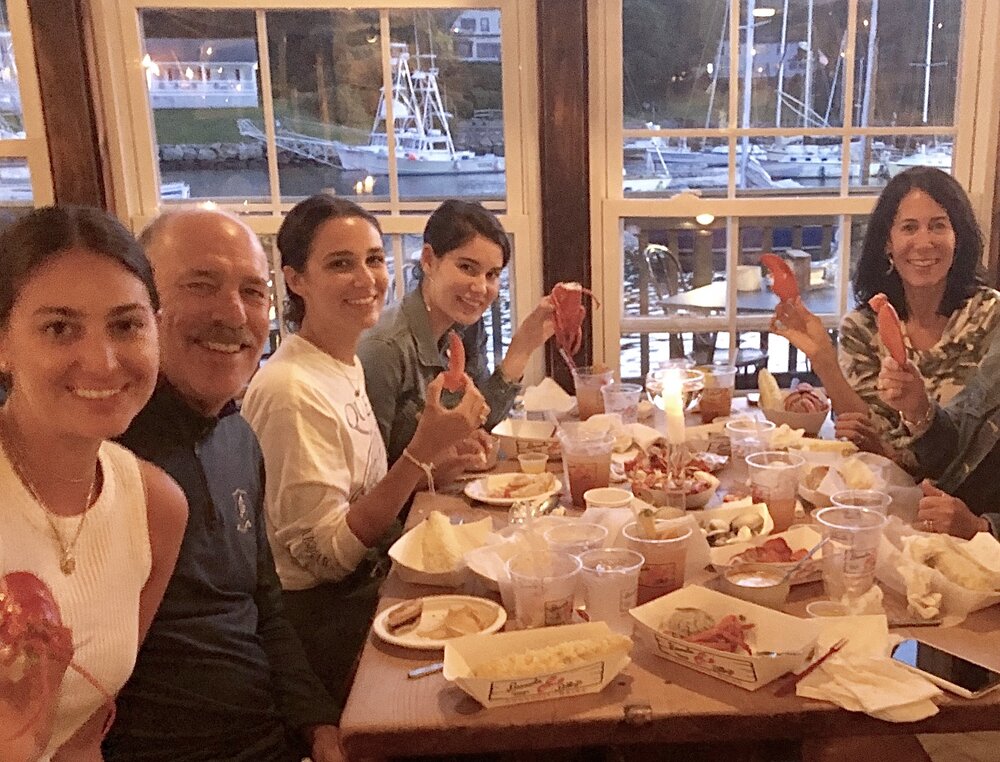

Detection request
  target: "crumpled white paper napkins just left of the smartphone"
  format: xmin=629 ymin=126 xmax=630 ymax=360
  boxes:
xmin=796 ymin=615 xmax=941 ymax=722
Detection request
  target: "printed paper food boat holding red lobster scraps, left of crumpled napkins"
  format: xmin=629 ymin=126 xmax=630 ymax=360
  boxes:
xmin=629 ymin=585 xmax=819 ymax=691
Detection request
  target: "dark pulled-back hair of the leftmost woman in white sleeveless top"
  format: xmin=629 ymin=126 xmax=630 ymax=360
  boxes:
xmin=0 ymin=205 xmax=160 ymax=327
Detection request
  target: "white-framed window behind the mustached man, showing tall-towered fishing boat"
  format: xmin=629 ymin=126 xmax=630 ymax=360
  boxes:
xmin=94 ymin=0 xmax=541 ymax=378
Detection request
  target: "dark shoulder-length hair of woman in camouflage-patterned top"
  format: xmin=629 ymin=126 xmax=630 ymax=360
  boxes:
xmin=853 ymin=167 xmax=983 ymax=320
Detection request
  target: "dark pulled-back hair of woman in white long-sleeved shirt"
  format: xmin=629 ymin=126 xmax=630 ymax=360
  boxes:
xmin=278 ymin=193 xmax=382 ymax=331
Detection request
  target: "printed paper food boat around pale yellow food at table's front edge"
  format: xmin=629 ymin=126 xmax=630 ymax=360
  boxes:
xmin=444 ymin=622 xmax=631 ymax=708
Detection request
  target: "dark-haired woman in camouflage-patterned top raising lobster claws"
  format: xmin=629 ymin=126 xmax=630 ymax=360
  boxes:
xmin=771 ymin=167 xmax=1000 ymax=465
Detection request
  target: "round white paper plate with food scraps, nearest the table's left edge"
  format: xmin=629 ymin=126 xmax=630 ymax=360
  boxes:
xmin=372 ymin=595 xmax=507 ymax=651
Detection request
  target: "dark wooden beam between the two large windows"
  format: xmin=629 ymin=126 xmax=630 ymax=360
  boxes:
xmin=537 ymin=0 xmax=588 ymax=389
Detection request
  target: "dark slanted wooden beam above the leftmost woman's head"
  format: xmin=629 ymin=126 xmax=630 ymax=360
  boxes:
xmin=28 ymin=0 xmax=107 ymax=208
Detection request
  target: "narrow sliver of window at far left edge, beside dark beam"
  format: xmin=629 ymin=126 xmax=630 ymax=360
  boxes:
xmin=0 ymin=0 xmax=53 ymax=211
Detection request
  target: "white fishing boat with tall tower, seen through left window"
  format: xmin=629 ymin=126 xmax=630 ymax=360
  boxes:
xmin=335 ymin=42 xmax=504 ymax=175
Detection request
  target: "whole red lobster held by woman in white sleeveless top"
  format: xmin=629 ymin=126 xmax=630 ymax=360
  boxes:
xmin=0 ymin=571 xmax=115 ymax=740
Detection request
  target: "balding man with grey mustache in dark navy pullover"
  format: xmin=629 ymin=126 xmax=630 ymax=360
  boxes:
xmin=104 ymin=210 xmax=342 ymax=762
